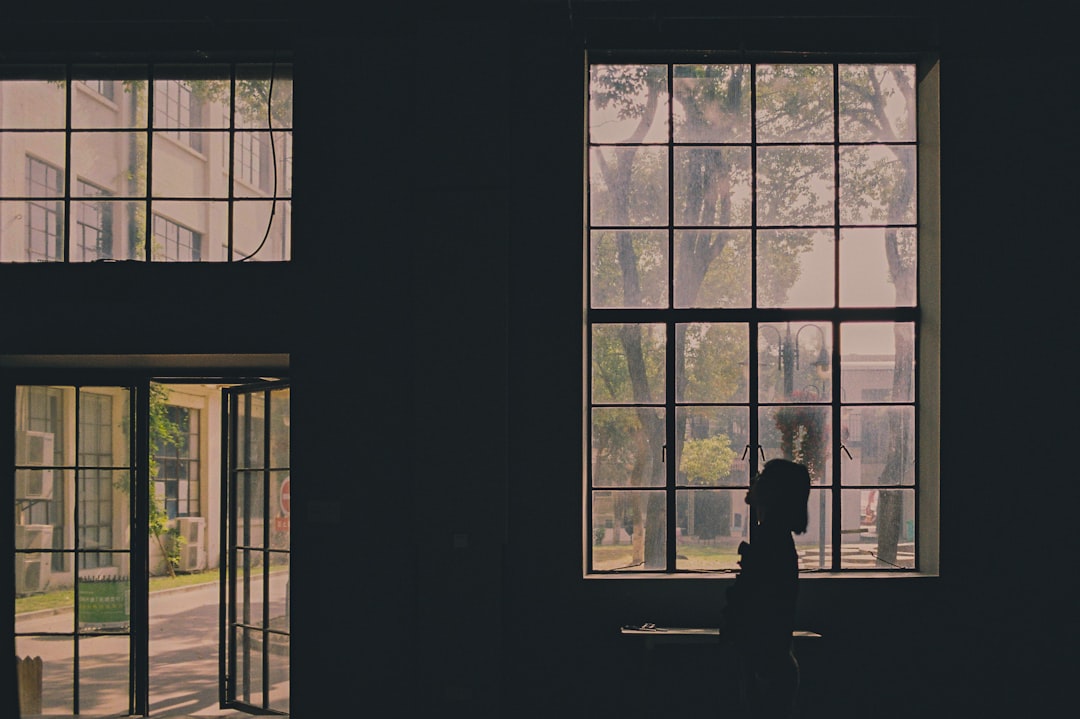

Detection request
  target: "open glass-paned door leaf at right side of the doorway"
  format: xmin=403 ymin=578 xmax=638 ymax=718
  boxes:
xmin=219 ymin=382 xmax=291 ymax=715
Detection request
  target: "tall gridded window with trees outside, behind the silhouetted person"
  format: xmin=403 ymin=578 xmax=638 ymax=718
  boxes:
xmin=585 ymin=57 xmax=922 ymax=573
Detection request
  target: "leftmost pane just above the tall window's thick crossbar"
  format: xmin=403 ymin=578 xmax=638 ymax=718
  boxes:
xmin=590 ymin=230 xmax=667 ymax=308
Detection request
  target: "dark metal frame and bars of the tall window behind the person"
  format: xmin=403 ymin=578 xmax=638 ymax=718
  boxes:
xmin=581 ymin=49 xmax=941 ymax=579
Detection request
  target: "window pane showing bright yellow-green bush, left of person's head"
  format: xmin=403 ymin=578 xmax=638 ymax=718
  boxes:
xmin=675 ymin=407 xmax=750 ymax=488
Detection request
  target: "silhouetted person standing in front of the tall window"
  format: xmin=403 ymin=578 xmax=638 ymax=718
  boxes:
xmin=723 ymin=459 xmax=810 ymax=719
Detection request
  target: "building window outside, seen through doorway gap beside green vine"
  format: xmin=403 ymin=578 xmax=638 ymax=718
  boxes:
xmin=154 ymin=405 xmax=200 ymax=519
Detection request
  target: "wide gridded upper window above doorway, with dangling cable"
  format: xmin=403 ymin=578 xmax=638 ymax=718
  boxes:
xmin=0 ymin=63 xmax=293 ymax=262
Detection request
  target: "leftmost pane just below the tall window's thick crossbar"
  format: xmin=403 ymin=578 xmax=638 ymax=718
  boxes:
xmin=592 ymin=324 xmax=667 ymax=404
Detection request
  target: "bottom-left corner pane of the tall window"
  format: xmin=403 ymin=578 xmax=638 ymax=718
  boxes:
xmin=590 ymin=490 xmax=667 ymax=571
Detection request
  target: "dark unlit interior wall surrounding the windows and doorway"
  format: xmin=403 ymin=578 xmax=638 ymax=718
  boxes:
xmin=0 ymin=0 xmax=1077 ymax=719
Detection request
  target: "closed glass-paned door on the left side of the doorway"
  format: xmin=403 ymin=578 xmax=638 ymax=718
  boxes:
xmin=6 ymin=384 xmax=146 ymax=717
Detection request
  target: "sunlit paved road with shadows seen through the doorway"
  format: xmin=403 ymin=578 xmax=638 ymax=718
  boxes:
xmin=16 ymin=572 xmax=288 ymax=719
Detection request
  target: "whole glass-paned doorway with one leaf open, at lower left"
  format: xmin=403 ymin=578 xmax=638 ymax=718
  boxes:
xmin=13 ymin=377 xmax=291 ymax=718
